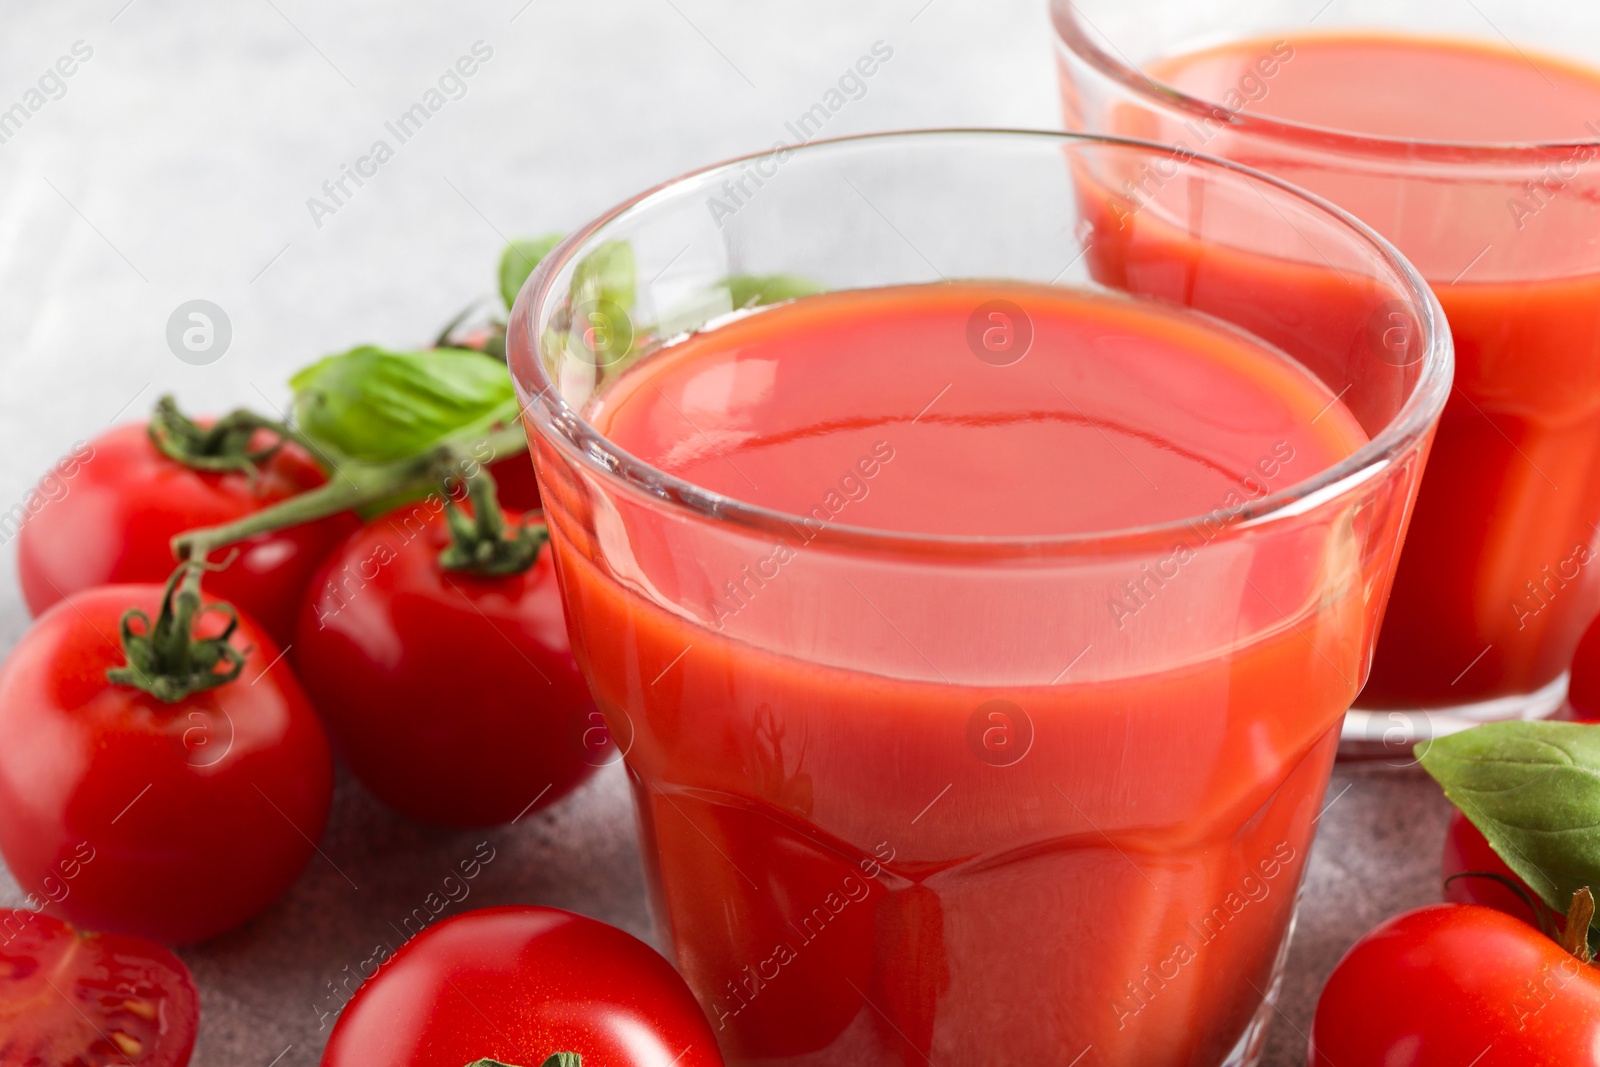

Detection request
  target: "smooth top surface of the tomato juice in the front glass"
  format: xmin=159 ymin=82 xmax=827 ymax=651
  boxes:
xmin=589 ymin=286 xmax=1360 ymax=536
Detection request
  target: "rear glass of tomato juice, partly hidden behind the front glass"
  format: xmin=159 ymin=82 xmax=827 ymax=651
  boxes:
xmin=1053 ymin=0 xmax=1600 ymax=753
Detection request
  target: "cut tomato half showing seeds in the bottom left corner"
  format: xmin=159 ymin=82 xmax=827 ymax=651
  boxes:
xmin=0 ymin=910 xmax=200 ymax=1067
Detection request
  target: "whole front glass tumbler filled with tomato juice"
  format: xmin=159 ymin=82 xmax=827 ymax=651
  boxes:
xmin=510 ymin=131 xmax=1451 ymax=1067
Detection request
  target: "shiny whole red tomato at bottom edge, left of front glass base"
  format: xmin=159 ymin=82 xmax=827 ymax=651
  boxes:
xmin=322 ymin=907 xmax=722 ymax=1067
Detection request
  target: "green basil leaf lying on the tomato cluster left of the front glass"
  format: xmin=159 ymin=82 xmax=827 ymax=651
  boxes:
xmin=290 ymin=346 xmax=515 ymax=462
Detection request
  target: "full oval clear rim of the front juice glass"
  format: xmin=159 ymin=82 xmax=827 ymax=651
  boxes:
xmin=506 ymin=128 xmax=1454 ymax=558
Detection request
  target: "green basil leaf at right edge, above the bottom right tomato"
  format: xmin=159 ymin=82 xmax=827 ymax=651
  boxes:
xmin=1416 ymin=721 xmax=1600 ymax=915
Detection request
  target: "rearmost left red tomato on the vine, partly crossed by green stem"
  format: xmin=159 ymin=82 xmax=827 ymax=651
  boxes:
xmin=15 ymin=422 xmax=355 ymax=646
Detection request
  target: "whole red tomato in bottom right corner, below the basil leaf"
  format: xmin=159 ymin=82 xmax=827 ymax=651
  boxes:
xmin=1310 ymin=904 xmax=1600 ymax=1067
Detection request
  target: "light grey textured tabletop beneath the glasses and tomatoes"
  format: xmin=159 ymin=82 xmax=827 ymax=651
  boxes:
xmin=0 ymin=0 xmax=1445 ymax=1067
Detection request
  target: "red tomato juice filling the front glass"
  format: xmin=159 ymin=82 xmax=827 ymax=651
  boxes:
xmin=547 ymin=283 xmax=1374 ymax=1067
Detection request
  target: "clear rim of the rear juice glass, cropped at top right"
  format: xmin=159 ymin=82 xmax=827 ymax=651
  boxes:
xmin=1050 ymin=0 xmax=1600 ymax=166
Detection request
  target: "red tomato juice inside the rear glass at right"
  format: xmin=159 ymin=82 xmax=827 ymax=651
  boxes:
xmin=1145 ymin=35 xmax=1600 ymax=707
